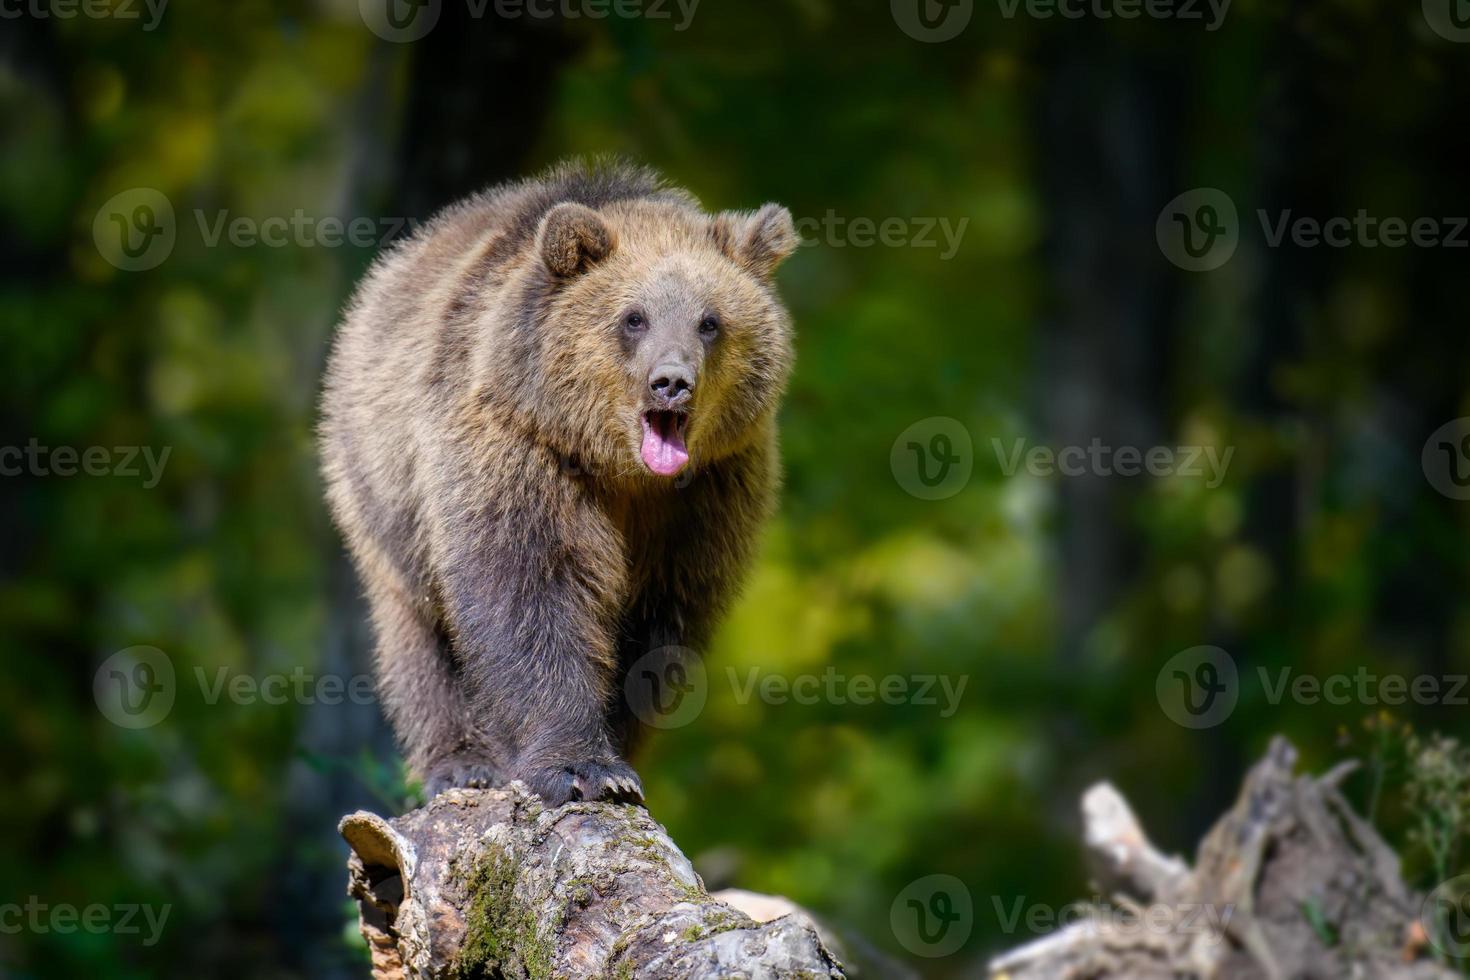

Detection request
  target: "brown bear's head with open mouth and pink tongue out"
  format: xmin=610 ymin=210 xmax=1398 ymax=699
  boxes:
xmin=531 ymin=198 xmax=797 ymax=482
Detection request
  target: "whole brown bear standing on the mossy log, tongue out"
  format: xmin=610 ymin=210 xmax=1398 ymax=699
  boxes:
xmin=320 ymin=162 xmax=797 ymax=805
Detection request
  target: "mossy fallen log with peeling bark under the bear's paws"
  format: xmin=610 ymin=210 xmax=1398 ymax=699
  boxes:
xmin=338 ymin=783 xmax=844 ymax=980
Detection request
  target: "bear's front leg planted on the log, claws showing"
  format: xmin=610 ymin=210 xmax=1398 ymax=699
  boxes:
xmin=442 ymin=487 xmax=642 ymax=807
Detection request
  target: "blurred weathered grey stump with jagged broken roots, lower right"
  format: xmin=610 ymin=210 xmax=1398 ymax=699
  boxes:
xmin=989 ymin=738 xmax=1460 ymax=980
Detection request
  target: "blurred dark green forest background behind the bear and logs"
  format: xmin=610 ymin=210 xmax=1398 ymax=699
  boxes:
xmin=0 ymin=0 xmax=1470 ymax=977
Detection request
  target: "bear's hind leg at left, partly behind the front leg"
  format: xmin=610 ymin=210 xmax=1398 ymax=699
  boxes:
xmin=369 ymin=575 xmax=503 ymax=799
